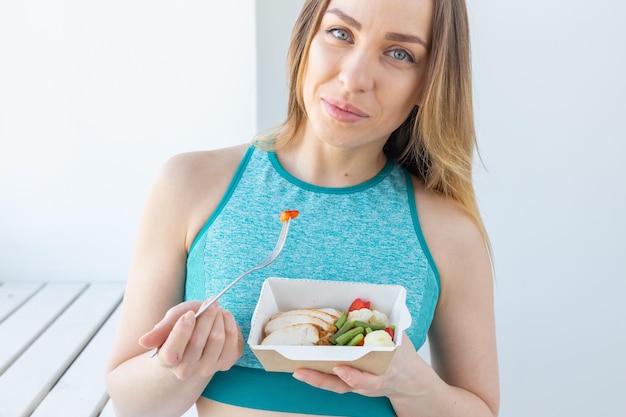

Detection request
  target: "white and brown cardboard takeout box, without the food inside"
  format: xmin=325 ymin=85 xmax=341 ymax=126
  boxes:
xmin=248 ymin=278 xmax=411 ymax=375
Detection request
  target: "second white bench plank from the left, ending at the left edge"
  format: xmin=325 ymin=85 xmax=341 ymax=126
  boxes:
xmin=0 ymin=283 xmax=86 ymax=375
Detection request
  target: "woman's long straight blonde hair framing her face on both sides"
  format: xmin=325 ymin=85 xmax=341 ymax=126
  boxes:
xmin=258 ymin=0 xmax=489 ymax=246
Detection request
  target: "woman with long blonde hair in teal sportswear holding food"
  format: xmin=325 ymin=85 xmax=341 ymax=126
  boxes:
xmin=107 ymin=0 xmax=499 ymax=417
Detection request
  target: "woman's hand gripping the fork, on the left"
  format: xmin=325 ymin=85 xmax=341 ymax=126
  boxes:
xmin=139 ymin=301 xmax=243 ymax=380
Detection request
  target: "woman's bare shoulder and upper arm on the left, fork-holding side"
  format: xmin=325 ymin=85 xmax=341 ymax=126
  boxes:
xmin=108 ymin=148 xmax=242 ymax=371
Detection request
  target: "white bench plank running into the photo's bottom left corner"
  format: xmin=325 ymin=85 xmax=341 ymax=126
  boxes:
xmin=0 ymin=283 xmax=122 ymax=416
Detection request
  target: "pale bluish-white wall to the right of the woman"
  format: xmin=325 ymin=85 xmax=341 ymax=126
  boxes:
xmin=468 ymin=0 xmax=626 ymax=417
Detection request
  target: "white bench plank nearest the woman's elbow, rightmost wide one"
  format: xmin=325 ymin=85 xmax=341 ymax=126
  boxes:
xmin=31 ymin=307 xmax=119 ymax=417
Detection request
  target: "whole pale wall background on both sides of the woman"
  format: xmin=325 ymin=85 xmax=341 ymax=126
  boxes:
xmin=0 ymin=0 xmax=626 ymax=417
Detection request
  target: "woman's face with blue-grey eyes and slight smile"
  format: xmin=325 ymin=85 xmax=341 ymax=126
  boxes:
xmin=303 ymin=0 xmax=433 ymax=148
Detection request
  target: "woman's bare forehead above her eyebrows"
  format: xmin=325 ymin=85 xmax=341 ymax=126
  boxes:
xmin=324 ymin=0 xmax=434 ymax=43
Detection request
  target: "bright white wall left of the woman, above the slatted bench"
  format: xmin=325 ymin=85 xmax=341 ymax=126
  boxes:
xmin=0 ymin=0 xmax=256 ymax=281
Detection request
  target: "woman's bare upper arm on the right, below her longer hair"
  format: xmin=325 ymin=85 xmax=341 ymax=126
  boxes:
xmin=416 ymin=178 xmax=499 ymax=412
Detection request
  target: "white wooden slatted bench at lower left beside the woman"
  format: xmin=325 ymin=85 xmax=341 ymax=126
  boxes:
xmin=0 ymin=281 xmax=196 ymax=417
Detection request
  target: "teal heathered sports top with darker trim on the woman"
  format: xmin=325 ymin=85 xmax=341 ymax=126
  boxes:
xmin=185 ymin=146 xmax=439 ymax=417
